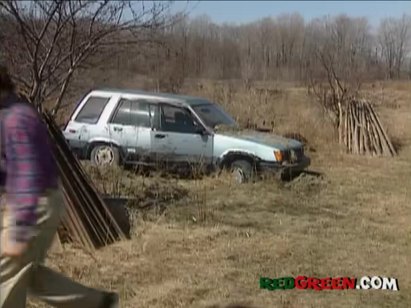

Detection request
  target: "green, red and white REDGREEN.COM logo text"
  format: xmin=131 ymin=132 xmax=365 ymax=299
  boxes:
xmin=260 ymin=276 xmax=400 ymax=291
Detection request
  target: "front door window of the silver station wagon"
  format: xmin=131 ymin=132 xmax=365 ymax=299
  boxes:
xmin=161 ymin=105 xmax=198 ymax=134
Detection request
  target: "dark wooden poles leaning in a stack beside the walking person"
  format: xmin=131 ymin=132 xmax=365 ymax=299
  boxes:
xmin=43 ymin=113 xmax=127 ymax=250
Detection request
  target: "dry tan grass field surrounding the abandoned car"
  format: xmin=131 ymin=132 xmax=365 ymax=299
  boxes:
xmin=30 ymin=82 xmax=411 ymax=308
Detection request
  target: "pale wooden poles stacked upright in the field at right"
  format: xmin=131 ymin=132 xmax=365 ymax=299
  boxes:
xmin=341 ymin=99 xmax=396 ymax=156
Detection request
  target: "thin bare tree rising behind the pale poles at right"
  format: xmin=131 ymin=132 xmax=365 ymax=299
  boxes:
xmin=308 ymin=15 xmax=370 ymax=143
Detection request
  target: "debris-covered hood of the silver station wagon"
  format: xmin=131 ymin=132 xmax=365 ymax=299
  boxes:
xmin=217 ymin=130 xmax=303 ymax=150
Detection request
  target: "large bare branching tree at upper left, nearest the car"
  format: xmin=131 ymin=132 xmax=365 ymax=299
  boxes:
xmin=0 ymin=0 xmax=175 ymax=113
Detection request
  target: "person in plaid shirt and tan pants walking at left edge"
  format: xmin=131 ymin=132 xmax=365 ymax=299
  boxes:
xmin=0 ymin=66 xmax=119 ymax=308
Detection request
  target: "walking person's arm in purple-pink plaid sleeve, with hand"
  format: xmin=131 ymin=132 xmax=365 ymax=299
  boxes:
xmin=4 ymin=107 xmax=44 ymax=243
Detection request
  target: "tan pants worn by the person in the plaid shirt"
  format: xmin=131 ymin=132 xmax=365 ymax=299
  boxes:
xmin=0 ymin=190 xmax=108 ymax=308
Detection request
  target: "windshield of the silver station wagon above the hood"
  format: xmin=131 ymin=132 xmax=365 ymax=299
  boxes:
xmin=193 ymin=103 xmax=237 ymax=128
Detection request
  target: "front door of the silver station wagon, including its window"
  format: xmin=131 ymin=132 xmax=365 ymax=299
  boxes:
xmin=151 ymin=103 xmax=213 ymax=164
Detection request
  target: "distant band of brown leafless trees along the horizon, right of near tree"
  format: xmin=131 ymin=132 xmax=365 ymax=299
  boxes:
xmin=116 ymin=14 xmax=411 ymax=88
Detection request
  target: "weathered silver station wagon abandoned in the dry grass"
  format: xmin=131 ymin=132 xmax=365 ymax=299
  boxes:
xmin=63 ymin=89 xmax=310 ymax=182
